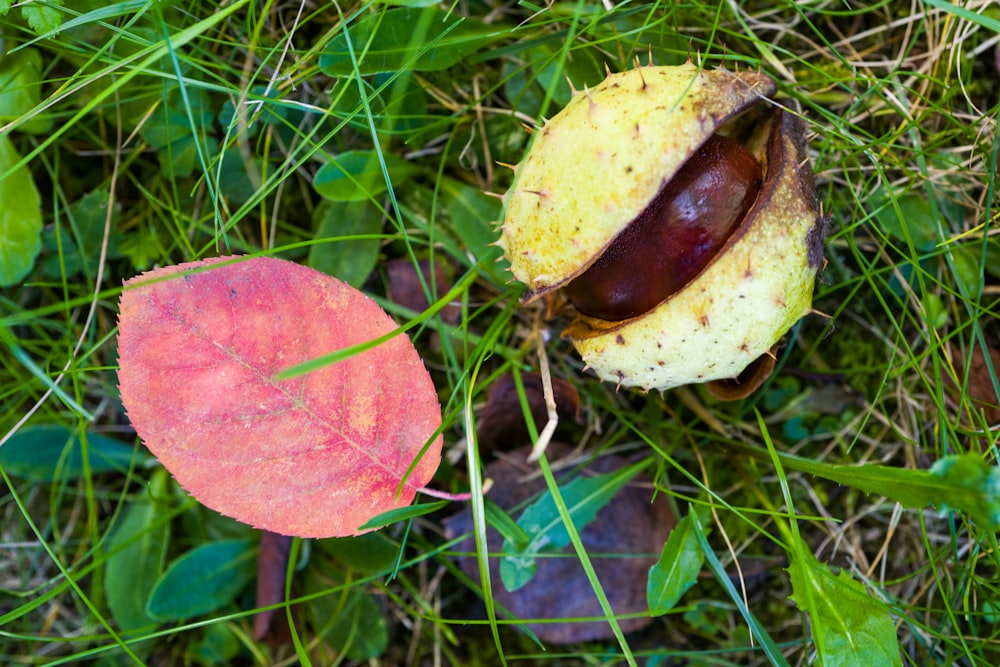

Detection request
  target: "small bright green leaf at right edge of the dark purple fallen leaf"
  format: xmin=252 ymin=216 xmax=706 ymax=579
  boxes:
xmin=646 ymin=510 xmax=705 ymax=616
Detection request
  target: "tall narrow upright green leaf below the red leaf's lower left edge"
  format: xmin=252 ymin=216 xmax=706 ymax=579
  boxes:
xmin=104 ymin=468 xmax=170 ymax=633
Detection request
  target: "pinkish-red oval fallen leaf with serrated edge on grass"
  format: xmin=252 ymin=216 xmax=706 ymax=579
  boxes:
xmin=118 ymin=257 xmax=441 ymax=537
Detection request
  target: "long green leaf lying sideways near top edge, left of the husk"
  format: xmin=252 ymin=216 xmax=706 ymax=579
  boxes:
xmin=319 ymin=7 xmax=510 ymax=77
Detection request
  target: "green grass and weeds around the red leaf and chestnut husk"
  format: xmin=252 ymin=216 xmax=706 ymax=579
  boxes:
xmin=0 ymin=0 xmax=1000 ymax=666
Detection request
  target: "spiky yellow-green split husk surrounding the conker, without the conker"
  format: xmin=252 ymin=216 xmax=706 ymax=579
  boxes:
xmin=500 ymin=63 xmax=822 ymax=390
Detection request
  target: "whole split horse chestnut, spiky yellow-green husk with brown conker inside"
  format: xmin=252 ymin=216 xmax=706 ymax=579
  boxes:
xmin=499 ymin=63 xmax=823 ymax=397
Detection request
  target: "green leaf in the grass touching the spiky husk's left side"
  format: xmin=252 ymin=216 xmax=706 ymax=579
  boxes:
xmin=442 ymin=179 xmax=510 ymax=285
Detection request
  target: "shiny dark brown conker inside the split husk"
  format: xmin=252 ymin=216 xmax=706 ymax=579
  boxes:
xmin=563 ymin=134 xmax=762 ymax=322
